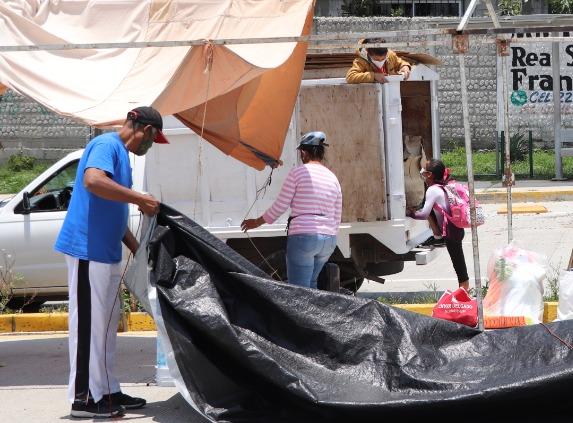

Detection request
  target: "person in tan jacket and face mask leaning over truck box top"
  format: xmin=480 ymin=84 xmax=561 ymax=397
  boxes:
xmin=346 ymin=38 xmax=411 ymax=84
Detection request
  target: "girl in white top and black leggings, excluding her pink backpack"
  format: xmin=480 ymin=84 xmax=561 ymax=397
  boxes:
xmin=406 ymin=159 xmax=470 ymax=291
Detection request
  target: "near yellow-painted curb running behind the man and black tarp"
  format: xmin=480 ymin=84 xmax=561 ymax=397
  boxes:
xmin=0 ymin=302 xmax=557 ymax=333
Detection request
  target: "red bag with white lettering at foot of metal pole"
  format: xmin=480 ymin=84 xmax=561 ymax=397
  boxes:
xmin=432 ymin=288 xmax=477 ymax=327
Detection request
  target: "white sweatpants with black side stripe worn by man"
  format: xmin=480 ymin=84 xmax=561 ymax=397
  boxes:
xmin=66 ymin=255 xmax=121 ymax=402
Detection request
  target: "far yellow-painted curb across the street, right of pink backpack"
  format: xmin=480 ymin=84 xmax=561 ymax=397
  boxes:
xmin=475 ymin=187 xmax=573 ymax=204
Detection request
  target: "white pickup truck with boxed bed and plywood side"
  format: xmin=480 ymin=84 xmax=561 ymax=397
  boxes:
xmin=0 ymin=65 xmax=438 ymax=304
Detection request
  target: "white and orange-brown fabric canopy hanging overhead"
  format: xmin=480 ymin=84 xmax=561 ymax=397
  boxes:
xmin=0 ymin=0 xmax=313 ymax=169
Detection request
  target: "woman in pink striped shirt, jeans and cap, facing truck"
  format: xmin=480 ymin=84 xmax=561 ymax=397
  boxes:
xmin=241 ymin=131 xmax=342 ymax=288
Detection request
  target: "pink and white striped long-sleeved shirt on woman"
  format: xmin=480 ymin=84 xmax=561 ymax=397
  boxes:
xmin=263 ymin=163 xmax=342 ymax=235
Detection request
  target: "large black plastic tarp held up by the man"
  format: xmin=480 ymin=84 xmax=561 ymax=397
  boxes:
xmin=149 ymin=206 xmax=573 ymax=422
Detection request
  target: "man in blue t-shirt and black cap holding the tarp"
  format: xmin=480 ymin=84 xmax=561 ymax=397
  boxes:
xmin=55 ymin=107 xmax=168 ymax=417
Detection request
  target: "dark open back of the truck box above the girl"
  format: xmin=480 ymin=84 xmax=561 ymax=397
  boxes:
xmin=400 ymin=81 xmax=433 ymax=159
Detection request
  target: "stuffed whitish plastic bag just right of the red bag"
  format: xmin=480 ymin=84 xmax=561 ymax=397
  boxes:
xmin=483 ymin=244 xmax=547 ymax=324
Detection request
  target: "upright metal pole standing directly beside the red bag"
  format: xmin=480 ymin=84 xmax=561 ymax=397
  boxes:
xmin=458 ymin=54 xmax=484 ymax=330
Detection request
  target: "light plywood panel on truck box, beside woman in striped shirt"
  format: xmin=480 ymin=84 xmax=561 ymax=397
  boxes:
xmin=299 ymin=83 xmax=387 ymax=222
